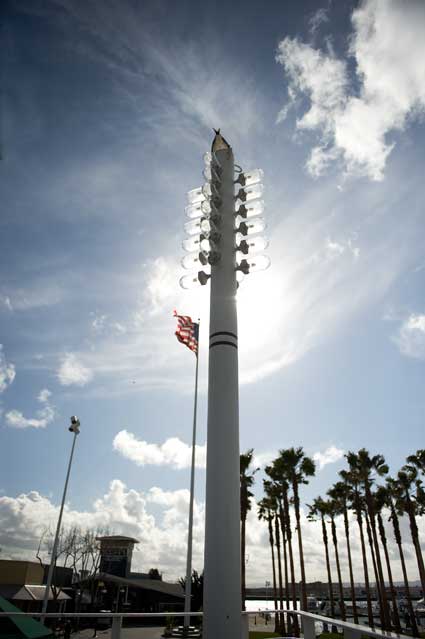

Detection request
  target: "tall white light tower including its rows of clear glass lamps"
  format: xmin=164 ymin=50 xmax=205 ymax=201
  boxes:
xmin=180 ymin=131 xmax=270 ymax=639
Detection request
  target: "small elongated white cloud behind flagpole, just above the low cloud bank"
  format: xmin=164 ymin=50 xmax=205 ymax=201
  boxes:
xmin=113 ymin=430 xmax=206 ymax=470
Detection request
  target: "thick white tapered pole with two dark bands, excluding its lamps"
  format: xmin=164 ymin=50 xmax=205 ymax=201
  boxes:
xmin=203 ymin=135 xmax=242 ymax=639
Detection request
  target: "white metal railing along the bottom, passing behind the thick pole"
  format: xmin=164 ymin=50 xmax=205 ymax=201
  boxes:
xmin=0 ymin=609 xmax=410 ymax=639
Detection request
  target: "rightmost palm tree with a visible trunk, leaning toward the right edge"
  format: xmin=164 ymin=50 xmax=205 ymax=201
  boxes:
xmin=397 ymin=465 xmax=425 ymax=594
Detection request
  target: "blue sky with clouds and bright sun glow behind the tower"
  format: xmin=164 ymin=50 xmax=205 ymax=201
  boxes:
xmin=0 ymin=0 xmax=425 ymax=583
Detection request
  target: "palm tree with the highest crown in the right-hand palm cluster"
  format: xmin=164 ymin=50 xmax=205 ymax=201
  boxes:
xmin=346 ymin=448 xmax=391 ymax=630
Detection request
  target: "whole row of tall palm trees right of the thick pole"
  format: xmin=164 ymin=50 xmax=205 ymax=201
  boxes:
xmin=241 ymin=447 xmax=425 ymax=636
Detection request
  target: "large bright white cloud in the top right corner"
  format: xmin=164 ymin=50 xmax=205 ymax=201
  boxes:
xmin=277 ymin=0 xmax=425 ymax=180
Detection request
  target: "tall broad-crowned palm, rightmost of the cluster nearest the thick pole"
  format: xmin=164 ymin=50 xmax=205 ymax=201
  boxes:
xmin=278 ymin=447 xmax=316 ymax=610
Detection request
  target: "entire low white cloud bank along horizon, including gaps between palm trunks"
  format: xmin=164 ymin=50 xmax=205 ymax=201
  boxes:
xmin=0 ymin=479 xmax=425 ymax=585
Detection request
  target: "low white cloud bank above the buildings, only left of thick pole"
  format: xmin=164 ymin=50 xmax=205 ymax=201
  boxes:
xmin=0 ymin=479 xmax=204 ymax=581
